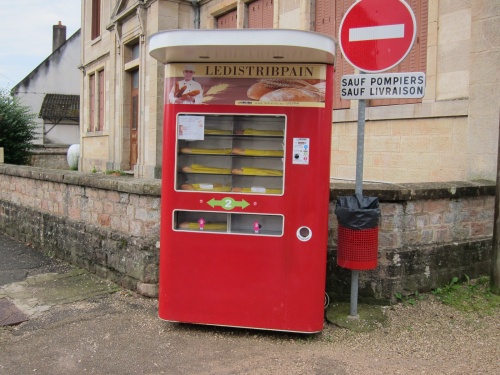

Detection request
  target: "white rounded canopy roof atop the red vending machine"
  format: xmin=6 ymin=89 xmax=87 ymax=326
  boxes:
xmin=149 ymin=29 xmax=335 ymax=64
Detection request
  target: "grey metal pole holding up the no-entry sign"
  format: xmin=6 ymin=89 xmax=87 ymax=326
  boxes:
xmin=349 ymin=81 xmax=366 ymax=318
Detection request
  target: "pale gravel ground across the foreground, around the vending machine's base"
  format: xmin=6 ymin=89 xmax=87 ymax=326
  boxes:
xmin=0 ymin=292 xmax=500 ymax=375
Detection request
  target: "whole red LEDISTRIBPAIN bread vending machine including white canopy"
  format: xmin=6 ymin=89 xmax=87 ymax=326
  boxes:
xmin=149 ymin=29 xmax=335 ymax=333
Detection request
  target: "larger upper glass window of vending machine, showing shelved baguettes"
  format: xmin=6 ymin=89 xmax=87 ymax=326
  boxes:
xmin=176 ymin=114 xmax=286 ymax=195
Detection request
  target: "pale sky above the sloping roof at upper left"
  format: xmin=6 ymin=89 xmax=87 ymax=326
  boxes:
xmin=0 ymin=0 xmax=82 ymax=90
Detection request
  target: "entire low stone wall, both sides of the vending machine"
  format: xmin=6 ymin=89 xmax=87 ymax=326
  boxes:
xmin=0 ymin=164 xmax=495 ymax=302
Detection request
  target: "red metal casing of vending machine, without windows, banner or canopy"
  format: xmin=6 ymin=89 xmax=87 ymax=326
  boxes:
xmin=149 ymin=30 xmax=334 ymax=333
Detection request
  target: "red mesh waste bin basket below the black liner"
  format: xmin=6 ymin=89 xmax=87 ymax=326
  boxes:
xmin=337 ymin=225 xmax=378 ymax=271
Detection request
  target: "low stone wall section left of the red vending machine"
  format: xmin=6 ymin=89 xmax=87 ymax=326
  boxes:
xmin=0 ymin=164 xmax=161 ymax=296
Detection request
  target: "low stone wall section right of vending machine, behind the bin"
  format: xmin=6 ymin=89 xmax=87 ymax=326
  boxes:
xmin=327 ymin=181 xmax=496 ymax=301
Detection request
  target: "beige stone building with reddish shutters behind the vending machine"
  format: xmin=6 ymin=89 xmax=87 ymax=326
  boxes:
xmin=80 ymin=0 xmax=500 ymax=183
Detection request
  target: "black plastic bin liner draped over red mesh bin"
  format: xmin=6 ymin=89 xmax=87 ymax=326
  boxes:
xmin=335 ymin=195 xmax=380 ymax=230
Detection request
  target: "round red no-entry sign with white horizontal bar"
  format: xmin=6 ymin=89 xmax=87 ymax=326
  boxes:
xmin=339 ymin=0 xmax=417 ymax=73
